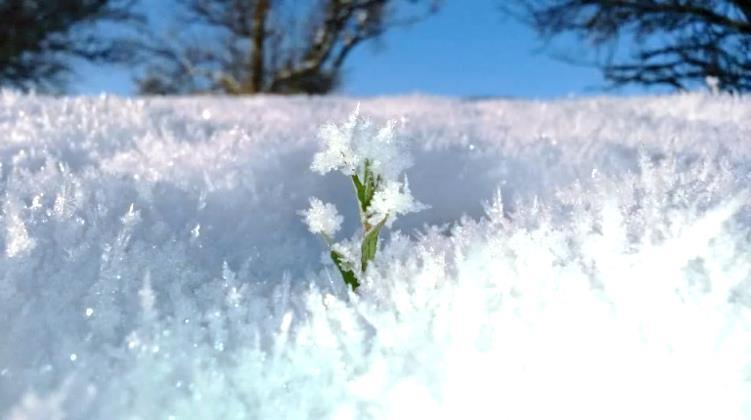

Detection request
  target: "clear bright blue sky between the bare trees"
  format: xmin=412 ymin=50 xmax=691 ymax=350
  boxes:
xmin=73 ymin=0 xmax=652 ymax=98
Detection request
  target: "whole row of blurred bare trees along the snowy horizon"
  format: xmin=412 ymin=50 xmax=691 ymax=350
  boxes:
xmin=0 ymin=0 xmax=751 ymax=95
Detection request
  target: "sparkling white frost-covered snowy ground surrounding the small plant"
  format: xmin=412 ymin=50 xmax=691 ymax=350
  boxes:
xmin=0 ymin=92 xmax=751 ymax=420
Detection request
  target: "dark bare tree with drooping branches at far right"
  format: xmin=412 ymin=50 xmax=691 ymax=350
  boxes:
xmin=501 ymin=0 xmax=751 ymax=92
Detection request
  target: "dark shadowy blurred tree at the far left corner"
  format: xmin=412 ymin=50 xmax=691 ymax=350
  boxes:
xmin=0 ymin=0 xmax=139 ymax=91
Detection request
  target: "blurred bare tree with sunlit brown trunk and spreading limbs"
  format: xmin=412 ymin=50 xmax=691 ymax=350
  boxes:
xmin=137 ymin=0 xmax=438 ymax=94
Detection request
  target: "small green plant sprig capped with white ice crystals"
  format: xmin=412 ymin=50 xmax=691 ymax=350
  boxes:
xmin=301 ymin=107 xmax=426 ymax=290
